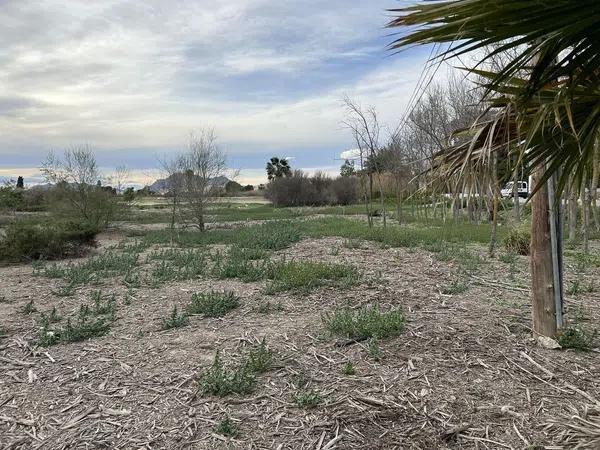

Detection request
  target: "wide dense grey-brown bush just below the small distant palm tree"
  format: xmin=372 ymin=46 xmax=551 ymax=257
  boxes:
xmin=265 ymin=170 xmax=358 ymax=207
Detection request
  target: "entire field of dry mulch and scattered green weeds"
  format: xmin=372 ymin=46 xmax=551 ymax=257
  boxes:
xmin=0 ymin=200 xmax=600 ymax=450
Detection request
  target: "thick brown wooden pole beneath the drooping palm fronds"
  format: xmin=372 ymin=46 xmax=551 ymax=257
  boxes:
xmin=531 ymin=167 xmax=557 ymax=338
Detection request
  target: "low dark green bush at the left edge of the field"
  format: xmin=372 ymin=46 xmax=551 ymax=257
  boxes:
xmin=0 ymin=221 xmax=98 ymax=262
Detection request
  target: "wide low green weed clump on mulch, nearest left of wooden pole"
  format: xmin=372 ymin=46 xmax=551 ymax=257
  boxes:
xmin=321 ymin=306 xmax=404 ymax=339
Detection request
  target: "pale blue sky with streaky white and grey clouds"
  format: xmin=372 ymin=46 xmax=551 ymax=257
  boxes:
xmin=0 ymin=0 xmax=429 ymax=185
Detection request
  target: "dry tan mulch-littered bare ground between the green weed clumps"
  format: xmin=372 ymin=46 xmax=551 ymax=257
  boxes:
xmin=0 ymin=230 xmax=600 ymax=450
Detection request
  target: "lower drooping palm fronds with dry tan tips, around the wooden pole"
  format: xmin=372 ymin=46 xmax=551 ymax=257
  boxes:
xmin=432 ymin=72 xmax=600 ymax=192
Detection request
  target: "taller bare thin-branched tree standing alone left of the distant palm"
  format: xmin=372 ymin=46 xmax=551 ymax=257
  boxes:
xmin=181 ymin=128 xmax=226 ymax=231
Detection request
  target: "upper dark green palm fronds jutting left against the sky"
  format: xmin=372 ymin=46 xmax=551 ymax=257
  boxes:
xmin=388 ymin=0 xmax=600 ymax=100
